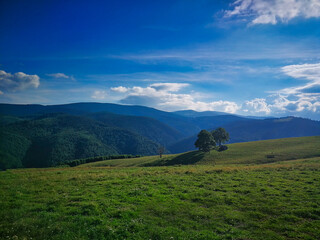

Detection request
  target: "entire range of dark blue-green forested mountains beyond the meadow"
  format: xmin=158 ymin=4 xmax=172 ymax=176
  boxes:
xmin=0 ymin=103 xmax=320 ymax=169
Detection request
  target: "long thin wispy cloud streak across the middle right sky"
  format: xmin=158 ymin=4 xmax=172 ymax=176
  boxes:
xmin=111 ymin=40 xmax=320 ymax=63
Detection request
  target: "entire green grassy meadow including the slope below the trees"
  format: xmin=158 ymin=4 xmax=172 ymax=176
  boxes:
xmin=0 ymin=137 xmax=320 ymax=240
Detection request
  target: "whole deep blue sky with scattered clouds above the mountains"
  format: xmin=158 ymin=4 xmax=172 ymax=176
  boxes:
xmin=0 ymin=0 xmax=320 ymax=120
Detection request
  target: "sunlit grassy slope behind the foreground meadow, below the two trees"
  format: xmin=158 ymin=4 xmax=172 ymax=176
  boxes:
xmin=79 ymin=136 xmax=320 ymax=167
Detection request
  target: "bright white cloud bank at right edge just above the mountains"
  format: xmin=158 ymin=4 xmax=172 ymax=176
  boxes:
xmin=242 ymin=63 xmax=320 ymax=117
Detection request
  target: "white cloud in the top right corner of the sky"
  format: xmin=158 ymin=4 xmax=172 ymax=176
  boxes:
xmin=225 ymin=0 xmax=320 ymax=24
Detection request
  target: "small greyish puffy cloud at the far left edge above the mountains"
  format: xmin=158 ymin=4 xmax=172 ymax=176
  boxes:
xmin=0 ymin=70 xmax=40 ymax=91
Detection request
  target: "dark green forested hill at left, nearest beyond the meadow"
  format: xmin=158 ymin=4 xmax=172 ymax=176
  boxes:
xmin=0 ymin=114 xmax=158 ymax=169
